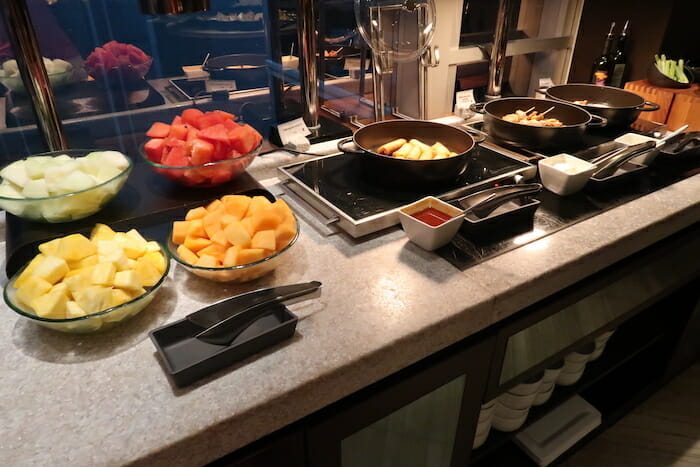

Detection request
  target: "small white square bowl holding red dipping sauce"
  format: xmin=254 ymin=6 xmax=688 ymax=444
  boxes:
xmin=399 ymin=196 xmax=464 ymax=251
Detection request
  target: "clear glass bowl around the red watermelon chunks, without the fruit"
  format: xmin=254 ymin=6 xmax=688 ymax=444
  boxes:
xmin=139 ymin=141 xmax=262 ymax=188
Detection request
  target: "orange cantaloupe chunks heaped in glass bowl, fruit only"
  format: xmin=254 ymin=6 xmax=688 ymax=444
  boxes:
xmin=172 ymin=195 xmax=297 ymax=268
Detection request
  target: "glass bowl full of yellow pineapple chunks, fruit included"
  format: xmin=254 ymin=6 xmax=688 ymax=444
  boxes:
xmin=4 ymin=224 xmax=170 ymax=333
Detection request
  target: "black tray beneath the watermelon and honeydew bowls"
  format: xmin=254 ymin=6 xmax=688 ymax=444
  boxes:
xmin=5 ymin=163 xmax=275 ymax=277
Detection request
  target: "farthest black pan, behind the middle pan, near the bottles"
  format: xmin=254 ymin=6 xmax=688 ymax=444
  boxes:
xmin=545 ymin=84 xmax=659 ymax=128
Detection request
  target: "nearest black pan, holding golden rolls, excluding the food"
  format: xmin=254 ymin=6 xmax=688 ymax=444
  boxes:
xmin=338 ymin=120 xmax=475 ymax=188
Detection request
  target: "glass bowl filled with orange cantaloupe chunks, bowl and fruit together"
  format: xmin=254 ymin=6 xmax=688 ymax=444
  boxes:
xmin=167 ymin=195 xmax=299 ymax=282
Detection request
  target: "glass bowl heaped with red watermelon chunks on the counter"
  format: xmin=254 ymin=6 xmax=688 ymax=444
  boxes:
xmin=141 ymin=108 xmax=263 ymax=187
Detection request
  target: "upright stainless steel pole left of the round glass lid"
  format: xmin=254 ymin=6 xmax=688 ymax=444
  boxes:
xmin=297 ymin=0 xmax=321 ymax=131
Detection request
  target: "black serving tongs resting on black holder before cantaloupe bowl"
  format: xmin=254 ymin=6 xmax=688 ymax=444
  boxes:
xmin=187 ymin=281 xmax=321 ymax=345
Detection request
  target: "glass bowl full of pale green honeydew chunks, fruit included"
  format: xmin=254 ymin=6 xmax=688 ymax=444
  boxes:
xmin=0 ymin=149 xmax=133 ymax=223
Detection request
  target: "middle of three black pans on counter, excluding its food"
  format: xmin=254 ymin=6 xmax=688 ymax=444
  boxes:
xmin=471 ymin=97 xmax=606 ymax=150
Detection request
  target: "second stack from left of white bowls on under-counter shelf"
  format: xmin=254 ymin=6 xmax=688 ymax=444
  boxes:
xmin=493 ymin=372 xmax=544 ymax=431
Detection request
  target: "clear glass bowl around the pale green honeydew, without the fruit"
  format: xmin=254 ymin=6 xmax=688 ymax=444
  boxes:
xmin=0 ymin=149 xmax=134 ymax=223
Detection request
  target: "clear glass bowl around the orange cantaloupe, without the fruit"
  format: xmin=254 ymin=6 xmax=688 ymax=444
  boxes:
xmin=166 ymin=214 xmax=299 ymax=283
